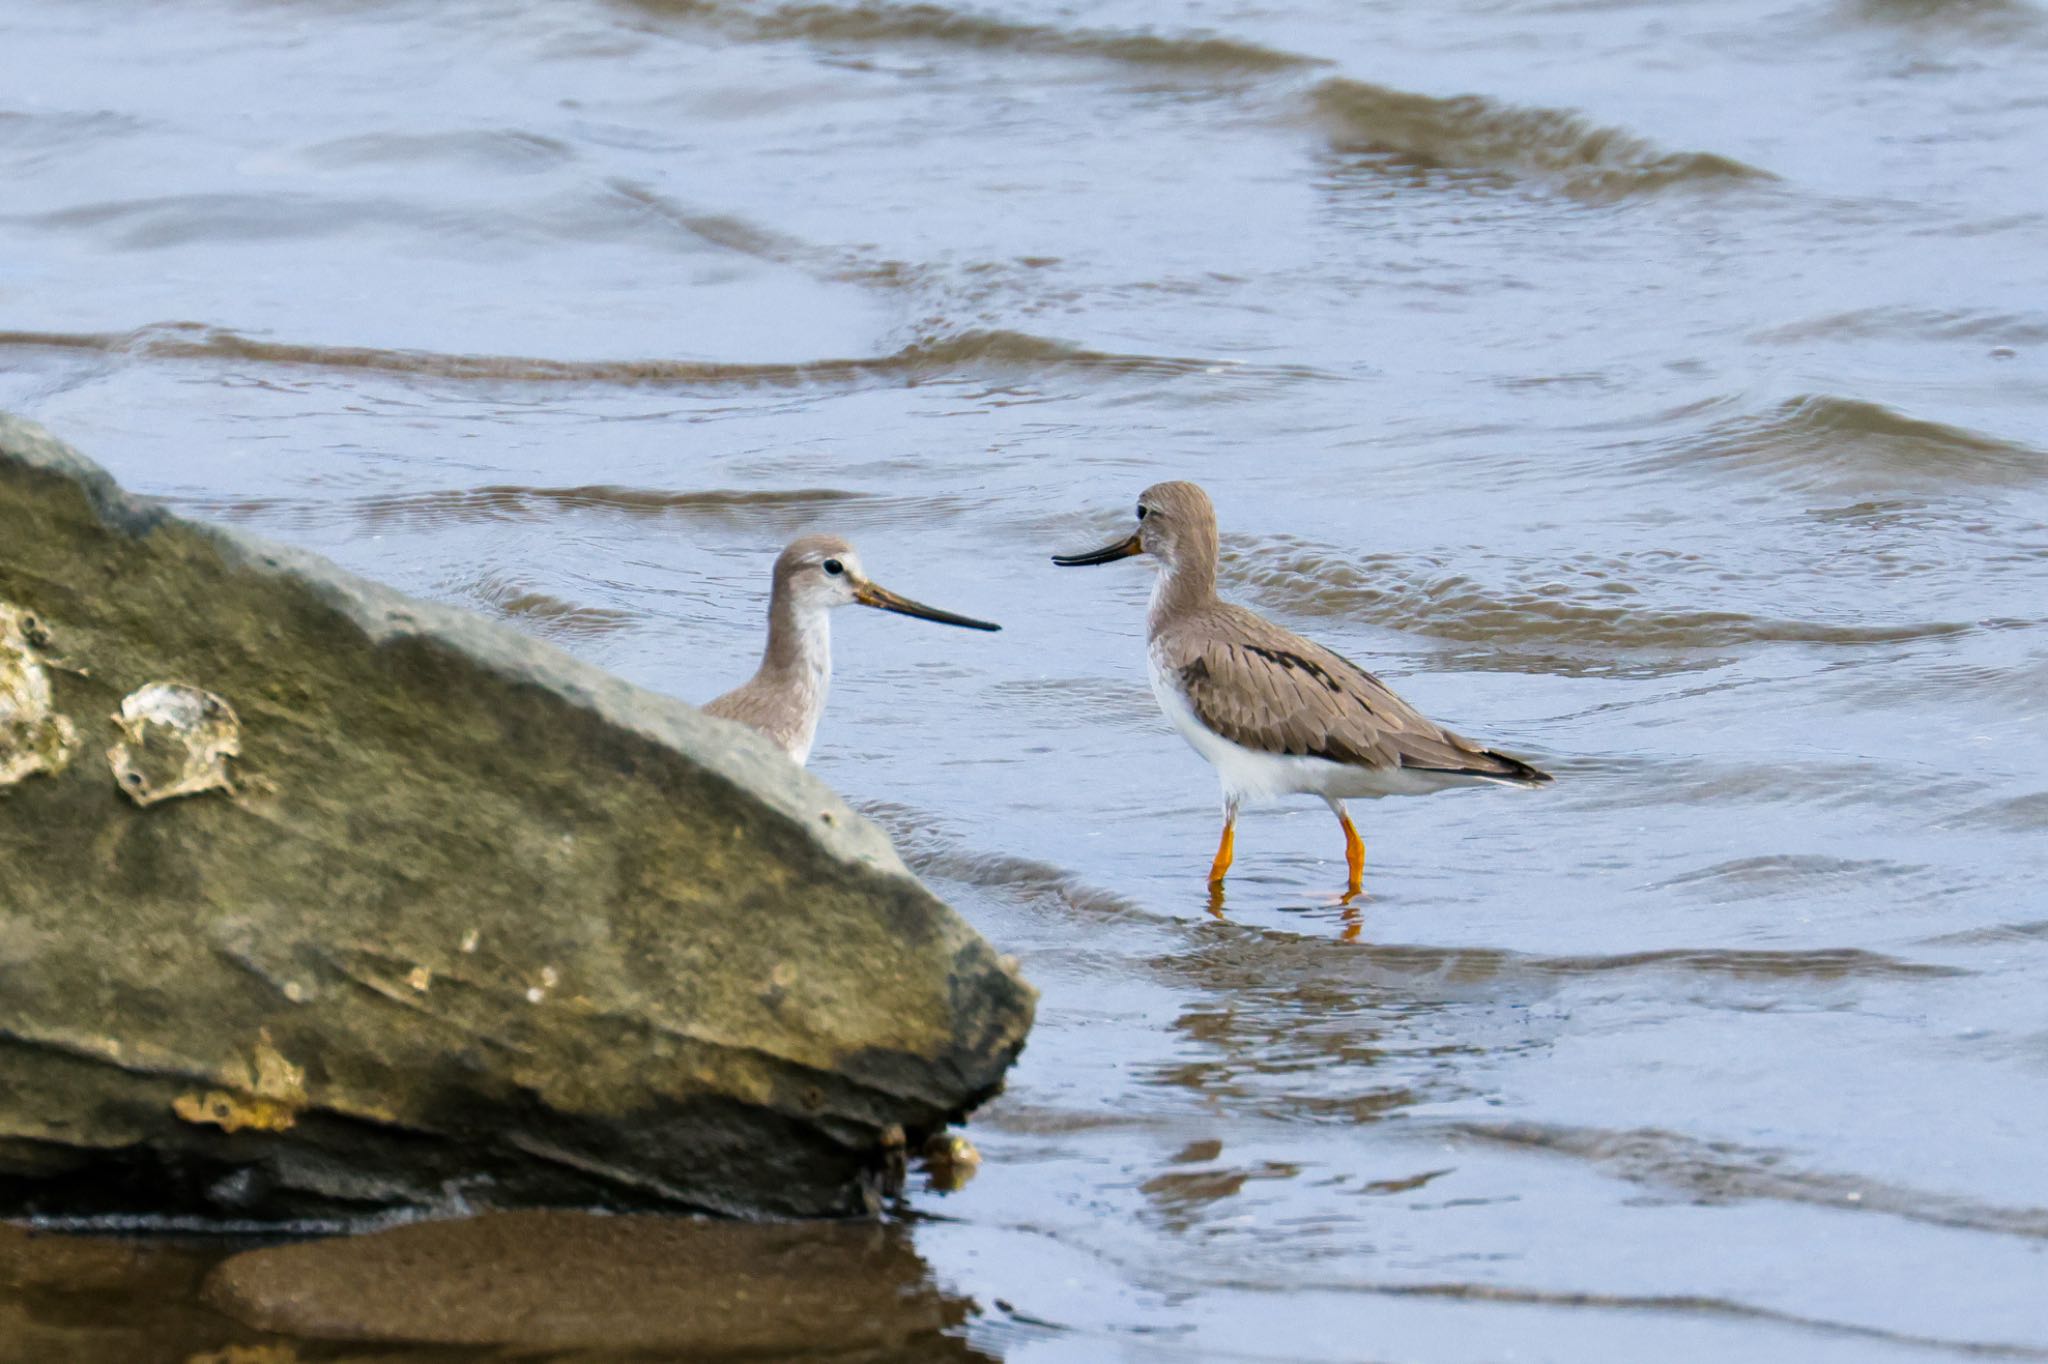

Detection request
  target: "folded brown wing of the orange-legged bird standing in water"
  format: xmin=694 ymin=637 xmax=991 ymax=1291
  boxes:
xmin=1159 ymin=604 xmax=1550 ymax=782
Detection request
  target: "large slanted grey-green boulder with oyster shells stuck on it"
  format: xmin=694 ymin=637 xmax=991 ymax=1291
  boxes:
xmin=0 ymin=416 xmax=1034 ymax=1219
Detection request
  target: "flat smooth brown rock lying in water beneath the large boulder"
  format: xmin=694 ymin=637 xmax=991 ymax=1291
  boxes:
xmin=203 ymin=1212 xmax=969 ymax=1360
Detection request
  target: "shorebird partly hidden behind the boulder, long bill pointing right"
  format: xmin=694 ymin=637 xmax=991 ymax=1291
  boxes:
xmin=705 ymin=535 xmax=1001 ymax=766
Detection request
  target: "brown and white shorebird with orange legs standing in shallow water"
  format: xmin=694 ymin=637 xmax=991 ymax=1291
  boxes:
xmin=1053 ymin=483 xmax=1550 ymax=901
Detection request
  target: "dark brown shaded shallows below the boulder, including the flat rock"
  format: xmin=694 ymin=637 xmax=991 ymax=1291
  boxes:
xmin=0 ymin=1212 xmax=991 ymax=1364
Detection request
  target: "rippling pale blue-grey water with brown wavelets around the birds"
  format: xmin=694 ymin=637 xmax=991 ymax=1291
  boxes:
xmin=0 ymin=0 xmax=2048 ymax=1362
